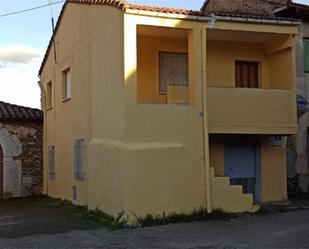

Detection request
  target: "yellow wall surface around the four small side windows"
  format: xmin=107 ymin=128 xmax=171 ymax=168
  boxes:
xmin=41 ymin=5 xmax=91 ymax=205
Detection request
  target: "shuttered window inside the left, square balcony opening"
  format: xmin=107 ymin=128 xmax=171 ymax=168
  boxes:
xmin=159 ymin=52 xmax=189 ymax=94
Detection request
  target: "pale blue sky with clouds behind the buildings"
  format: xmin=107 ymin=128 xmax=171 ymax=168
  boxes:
xmin=0 ymin=0 xmax=309 ymax=108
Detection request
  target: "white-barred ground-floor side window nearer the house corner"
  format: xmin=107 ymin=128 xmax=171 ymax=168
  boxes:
xmin=73 ymin=139 xmax=85 ymax=180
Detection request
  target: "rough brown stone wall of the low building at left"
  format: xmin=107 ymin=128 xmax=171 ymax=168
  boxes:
xmin=0 ymin=122 xmax=43 ymax=198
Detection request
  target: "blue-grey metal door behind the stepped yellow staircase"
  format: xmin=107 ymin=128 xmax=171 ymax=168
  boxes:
xmin=224 ymin=140 xmax=260 ymax=203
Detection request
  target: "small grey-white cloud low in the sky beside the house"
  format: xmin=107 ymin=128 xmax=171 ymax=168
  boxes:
xmin=0 ymin=45 xmax=43 ymax=68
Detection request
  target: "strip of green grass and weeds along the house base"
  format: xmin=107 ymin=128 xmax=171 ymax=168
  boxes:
xmin=0 ymin=196 xmax=235 ymax=230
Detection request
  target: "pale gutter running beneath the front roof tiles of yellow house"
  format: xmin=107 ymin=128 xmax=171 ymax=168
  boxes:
xmin=125 ymin=9 xmax=301 ymax=25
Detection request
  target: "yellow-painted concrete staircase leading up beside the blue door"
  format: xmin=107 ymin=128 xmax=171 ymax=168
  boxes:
xmin=210 ymin=167 xmax=259 ymax=213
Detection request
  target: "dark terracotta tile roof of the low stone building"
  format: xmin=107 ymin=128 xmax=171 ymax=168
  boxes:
xmin=0 ymin=101 xmax=43 ymax=122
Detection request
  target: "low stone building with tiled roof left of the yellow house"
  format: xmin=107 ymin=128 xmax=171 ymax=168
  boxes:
xmin=0 ymin=101 xmax=43 ymax=199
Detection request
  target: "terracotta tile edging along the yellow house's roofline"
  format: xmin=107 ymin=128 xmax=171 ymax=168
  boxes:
xmin=39 ymin=0 xmax=296 ymax=75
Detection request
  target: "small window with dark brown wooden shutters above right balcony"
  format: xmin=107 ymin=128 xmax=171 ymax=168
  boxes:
xmin=235 ymin=61 xmax=259 ymax=88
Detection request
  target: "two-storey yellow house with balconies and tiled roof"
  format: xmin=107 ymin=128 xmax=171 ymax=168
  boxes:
xmin=39 ymin=0 xmax=298 ymax=216
